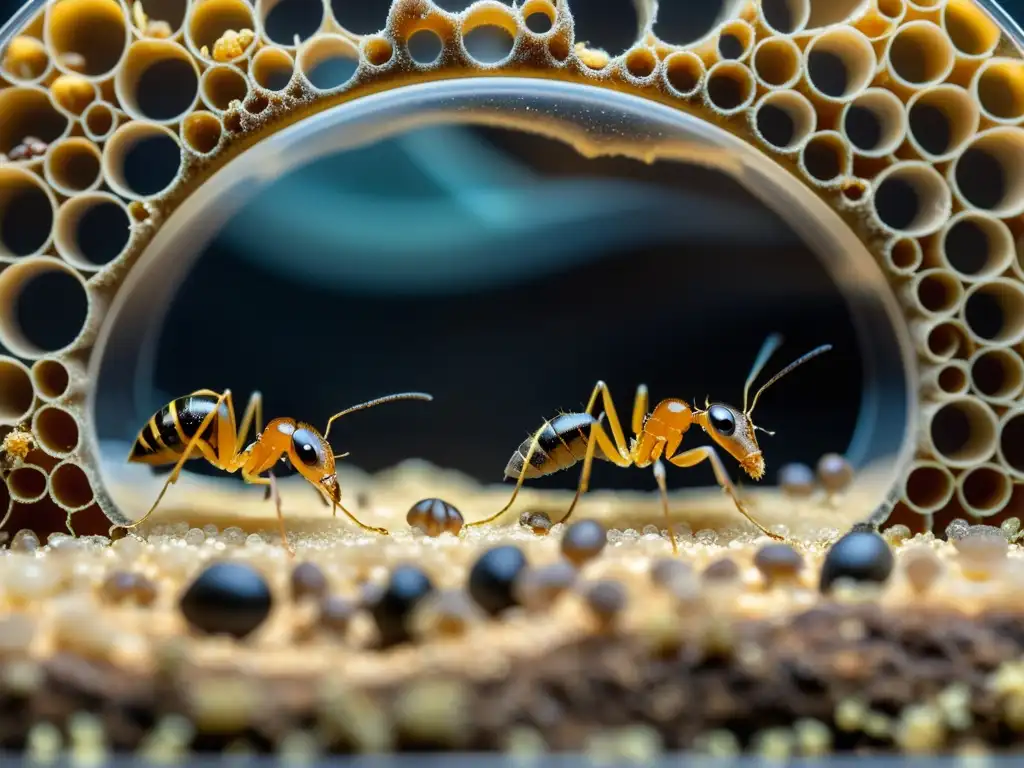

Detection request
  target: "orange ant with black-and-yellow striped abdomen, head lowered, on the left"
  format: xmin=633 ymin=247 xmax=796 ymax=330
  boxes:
xmin=120 ymin=389 xmax=433 ymax=552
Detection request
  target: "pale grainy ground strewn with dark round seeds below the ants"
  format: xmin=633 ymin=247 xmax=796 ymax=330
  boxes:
xmin=0 ymin=466 xmax=1024 ymax=761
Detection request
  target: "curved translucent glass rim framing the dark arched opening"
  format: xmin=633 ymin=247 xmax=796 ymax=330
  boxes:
xmin=85 ymin=78 xmax=919 ymax=528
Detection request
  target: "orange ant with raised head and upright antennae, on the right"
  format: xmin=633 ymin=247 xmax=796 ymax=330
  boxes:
xmin=467 ymin=334 xmax=831 ymax=553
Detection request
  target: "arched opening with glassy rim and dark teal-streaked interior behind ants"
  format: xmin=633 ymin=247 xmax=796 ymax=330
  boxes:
xmin=91 ymin=80 xmax=914 ymax=527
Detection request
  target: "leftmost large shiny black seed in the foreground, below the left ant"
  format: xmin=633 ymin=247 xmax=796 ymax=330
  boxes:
xmin=180 ymin=562 xmax=272 ymax=639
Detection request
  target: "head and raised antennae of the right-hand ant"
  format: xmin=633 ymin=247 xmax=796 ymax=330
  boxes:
xmin=694 ymin=334 xmax=831 ymax=480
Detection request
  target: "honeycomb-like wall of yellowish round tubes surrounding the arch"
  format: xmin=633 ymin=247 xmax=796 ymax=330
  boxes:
xmin=0 ymin=0 xmax=1024 ymax=536
